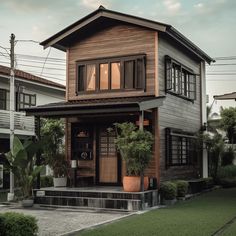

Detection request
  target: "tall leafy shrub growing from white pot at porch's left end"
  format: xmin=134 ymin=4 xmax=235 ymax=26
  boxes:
xmin=41 ymin=119 xmax=68 ymax=177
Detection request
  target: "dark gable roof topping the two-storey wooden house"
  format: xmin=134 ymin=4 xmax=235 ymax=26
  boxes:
xmin=40 ymin=6 xmax=214 ymax=63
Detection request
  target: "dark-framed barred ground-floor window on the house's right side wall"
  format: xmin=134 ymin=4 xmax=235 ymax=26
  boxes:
xmin=165 ymin=128 xmax=197 ymax=168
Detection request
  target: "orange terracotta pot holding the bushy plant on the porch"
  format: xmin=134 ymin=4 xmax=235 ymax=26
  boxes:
xmin=123 ymin=176 xmax=149 ymax=192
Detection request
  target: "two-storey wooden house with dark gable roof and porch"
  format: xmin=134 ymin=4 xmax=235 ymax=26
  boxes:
xmin=26 ymin=7 xmax=213 ymax=185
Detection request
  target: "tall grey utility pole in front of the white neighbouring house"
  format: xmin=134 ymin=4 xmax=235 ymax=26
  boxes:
xmin=7 ymin=34 xmax=15 ymax=201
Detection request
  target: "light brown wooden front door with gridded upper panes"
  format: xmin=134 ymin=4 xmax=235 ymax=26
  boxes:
xmin=98 ymin=127 xmax=119 ymax=184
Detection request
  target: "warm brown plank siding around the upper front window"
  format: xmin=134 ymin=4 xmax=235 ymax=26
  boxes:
xmin=67 ymin=24 xmax=155 ymax=100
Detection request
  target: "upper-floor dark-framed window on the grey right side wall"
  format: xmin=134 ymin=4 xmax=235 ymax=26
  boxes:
xmin=165 ymin=56 xmax=196 ymax=100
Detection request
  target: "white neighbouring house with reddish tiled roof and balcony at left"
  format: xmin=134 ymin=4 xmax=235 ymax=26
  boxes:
xmin=0 ymin=65 xmax=65 ymax=187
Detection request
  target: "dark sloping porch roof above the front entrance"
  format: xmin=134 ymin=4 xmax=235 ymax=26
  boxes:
xmin=24 ymin=96 xmax=165 ymax=117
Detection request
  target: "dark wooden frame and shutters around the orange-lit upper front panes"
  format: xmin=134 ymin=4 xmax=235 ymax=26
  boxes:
xmin=75 ymin=54 xmax=146 ymax=95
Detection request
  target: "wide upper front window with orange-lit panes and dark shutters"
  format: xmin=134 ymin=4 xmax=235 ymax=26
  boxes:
xmin=76 ymin=55 xmax=145 ymax=93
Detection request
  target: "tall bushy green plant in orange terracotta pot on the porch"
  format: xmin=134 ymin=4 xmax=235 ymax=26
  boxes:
xmin=115 ymin=122 xmax=153 ymax=192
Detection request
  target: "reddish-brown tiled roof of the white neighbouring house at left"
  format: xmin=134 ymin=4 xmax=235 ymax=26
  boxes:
xmin=0 ymin=65 xmax=65 ymax=89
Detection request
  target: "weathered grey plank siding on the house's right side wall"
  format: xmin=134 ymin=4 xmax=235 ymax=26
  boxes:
xmin=158 ymin=34 xmax=201 ymax=181
